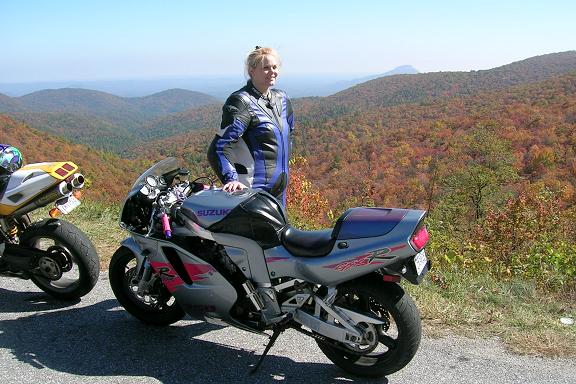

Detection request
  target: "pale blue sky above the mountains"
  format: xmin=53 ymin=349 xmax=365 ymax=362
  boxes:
xmin=0 ymin=0 xmax=576 ymax=83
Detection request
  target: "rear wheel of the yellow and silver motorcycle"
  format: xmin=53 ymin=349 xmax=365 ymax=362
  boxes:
xmin=20 ymin=219 xmax=100 ymax=300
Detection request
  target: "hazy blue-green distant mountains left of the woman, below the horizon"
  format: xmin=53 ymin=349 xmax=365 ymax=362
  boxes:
xmin=0 ymin=88 xmax=221 ymax=154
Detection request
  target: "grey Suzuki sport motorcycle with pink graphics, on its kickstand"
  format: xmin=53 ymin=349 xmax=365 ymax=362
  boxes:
xmin=109 ymin=158 xmax=430 ymax=376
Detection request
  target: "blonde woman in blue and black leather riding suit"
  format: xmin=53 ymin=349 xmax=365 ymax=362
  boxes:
xmin=208 ymin=46 xmax=294 ymax=205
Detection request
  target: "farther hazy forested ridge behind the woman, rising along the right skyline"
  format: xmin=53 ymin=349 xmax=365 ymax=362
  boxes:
xmin=119 ymin=51 xmax=576 ymax=137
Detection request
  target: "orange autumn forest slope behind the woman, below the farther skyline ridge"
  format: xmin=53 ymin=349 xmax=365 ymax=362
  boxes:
xmin=128 ymin=72 xmax=576 ymax=210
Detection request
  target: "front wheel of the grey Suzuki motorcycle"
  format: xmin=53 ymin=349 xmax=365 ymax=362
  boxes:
xmin=108 ymin=247 xmax=186 ymax=326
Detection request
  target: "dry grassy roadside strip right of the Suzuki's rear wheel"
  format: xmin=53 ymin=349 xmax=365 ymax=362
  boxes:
xmin=404 ymin=271 xmax=576 ymax=357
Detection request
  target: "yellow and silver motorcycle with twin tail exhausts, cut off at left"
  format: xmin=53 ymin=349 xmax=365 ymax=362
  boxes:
xmin=0 ymin=161 xmax=100 ymax=300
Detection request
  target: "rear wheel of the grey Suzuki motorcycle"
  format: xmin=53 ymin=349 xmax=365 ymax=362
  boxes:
xmin=317 ymin=278 xmax=422 ymax=377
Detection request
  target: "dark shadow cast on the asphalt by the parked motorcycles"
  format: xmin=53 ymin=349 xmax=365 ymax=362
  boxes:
xmin=0 ymin=289 xmax=388 ymax=384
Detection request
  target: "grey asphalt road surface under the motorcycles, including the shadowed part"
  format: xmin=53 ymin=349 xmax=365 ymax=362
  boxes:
xmin=0 ymin=275 xmax=576 ymax=384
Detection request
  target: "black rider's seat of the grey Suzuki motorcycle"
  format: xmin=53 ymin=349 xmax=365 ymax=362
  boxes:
xmin=281 ymin=226 xmax=336 ymax=257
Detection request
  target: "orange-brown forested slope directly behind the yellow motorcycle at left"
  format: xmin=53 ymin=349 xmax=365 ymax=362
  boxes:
xmin=0 ymin=114 xmax=143 ymax=202
